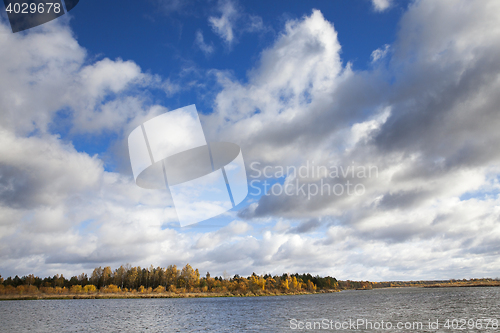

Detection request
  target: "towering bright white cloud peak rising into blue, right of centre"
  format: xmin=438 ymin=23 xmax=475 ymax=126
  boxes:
xmin=205 ymin=11 xmax=349 ymax=162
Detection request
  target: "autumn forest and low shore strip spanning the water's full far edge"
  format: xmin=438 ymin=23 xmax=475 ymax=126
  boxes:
xmin=0 ymin=264 xmax=500 ymax=299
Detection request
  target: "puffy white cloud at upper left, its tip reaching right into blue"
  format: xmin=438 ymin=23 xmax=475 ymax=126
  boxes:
xmin=0 ymin=22 xmax=172 ymax=134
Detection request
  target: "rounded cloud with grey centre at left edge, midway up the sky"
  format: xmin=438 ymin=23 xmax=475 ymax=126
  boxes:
xmin=0 ymin=130 xmax=103 ymax=208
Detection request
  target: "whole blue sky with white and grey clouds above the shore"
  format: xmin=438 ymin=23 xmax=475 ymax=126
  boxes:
xmin=0 ymin=0 xmax=500 ymax=281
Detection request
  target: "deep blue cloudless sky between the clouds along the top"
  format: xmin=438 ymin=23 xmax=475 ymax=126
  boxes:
xmin=64 ymin=0 xmax=408 ymax=166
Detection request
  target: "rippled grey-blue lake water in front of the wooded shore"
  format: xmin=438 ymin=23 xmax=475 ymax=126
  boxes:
xmin=0 ymin=287 xmax=500 ymax=332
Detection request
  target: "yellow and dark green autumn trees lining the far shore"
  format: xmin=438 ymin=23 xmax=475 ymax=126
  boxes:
xmin=0 ymin=264 xmax=340 ymax=295
